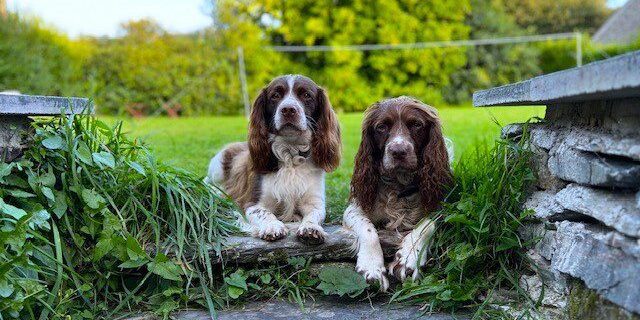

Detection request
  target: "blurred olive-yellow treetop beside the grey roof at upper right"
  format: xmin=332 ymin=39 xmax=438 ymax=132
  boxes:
xmin=504 ymin=0 xmax=611 ymax=33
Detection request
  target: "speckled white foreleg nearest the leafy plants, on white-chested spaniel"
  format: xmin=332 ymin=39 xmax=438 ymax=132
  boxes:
xmin=245 ymin=202 xmax=289 ymax=241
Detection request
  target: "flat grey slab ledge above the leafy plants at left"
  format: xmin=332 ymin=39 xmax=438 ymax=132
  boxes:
xmin=0 ymin=94 xmax=93 ymax=116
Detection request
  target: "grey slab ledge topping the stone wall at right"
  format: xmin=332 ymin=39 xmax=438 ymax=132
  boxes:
xmin=473 ymin=51 xmax=640 ymax=107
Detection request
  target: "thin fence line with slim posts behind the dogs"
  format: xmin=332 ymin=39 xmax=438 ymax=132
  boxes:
xmin=237 ymin=32 xmax=582 ymax=117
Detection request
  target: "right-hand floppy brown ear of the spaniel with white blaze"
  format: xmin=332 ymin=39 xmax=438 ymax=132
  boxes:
xmin=311 ymin=88 xmax=342 ymax=172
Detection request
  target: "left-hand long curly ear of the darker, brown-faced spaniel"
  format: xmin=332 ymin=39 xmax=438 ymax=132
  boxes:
xmin=351 ymin=105 xmax=380 ymax=212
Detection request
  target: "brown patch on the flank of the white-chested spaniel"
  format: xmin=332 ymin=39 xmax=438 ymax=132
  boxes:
xmin=222 ymin=142 xmax=260 ymax=209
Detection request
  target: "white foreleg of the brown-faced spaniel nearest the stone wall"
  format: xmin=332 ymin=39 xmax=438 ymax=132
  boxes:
xmin=389 ymin=219 xmax=435 ymax=281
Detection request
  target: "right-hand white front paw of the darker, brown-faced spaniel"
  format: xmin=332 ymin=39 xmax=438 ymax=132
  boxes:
xmin=388 ymin=238 xmax=427 ymax=281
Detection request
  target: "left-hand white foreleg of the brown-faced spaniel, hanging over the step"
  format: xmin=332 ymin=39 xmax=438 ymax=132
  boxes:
xmin=343 ymin=203 xmax=389 ymax=291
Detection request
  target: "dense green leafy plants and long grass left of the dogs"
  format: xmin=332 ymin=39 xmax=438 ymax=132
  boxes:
xmin=0 ymin=115 xmax=235 ymax=319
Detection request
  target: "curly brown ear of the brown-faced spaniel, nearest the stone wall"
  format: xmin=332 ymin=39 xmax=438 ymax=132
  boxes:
xmin=419 ymin=107 xmax=453 ymax=211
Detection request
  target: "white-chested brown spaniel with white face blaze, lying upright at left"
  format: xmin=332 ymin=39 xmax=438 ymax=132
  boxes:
xmin=206 ymin=75 xmax=341 ymax=244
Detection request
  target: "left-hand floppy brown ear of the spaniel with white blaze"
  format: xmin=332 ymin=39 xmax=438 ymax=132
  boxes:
xmin=247 ymin=89 xmax=278 ymax=173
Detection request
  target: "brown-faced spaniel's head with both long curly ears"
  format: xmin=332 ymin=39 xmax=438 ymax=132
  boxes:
xmin=351 ymin=97 xmax=452 ymax=211
